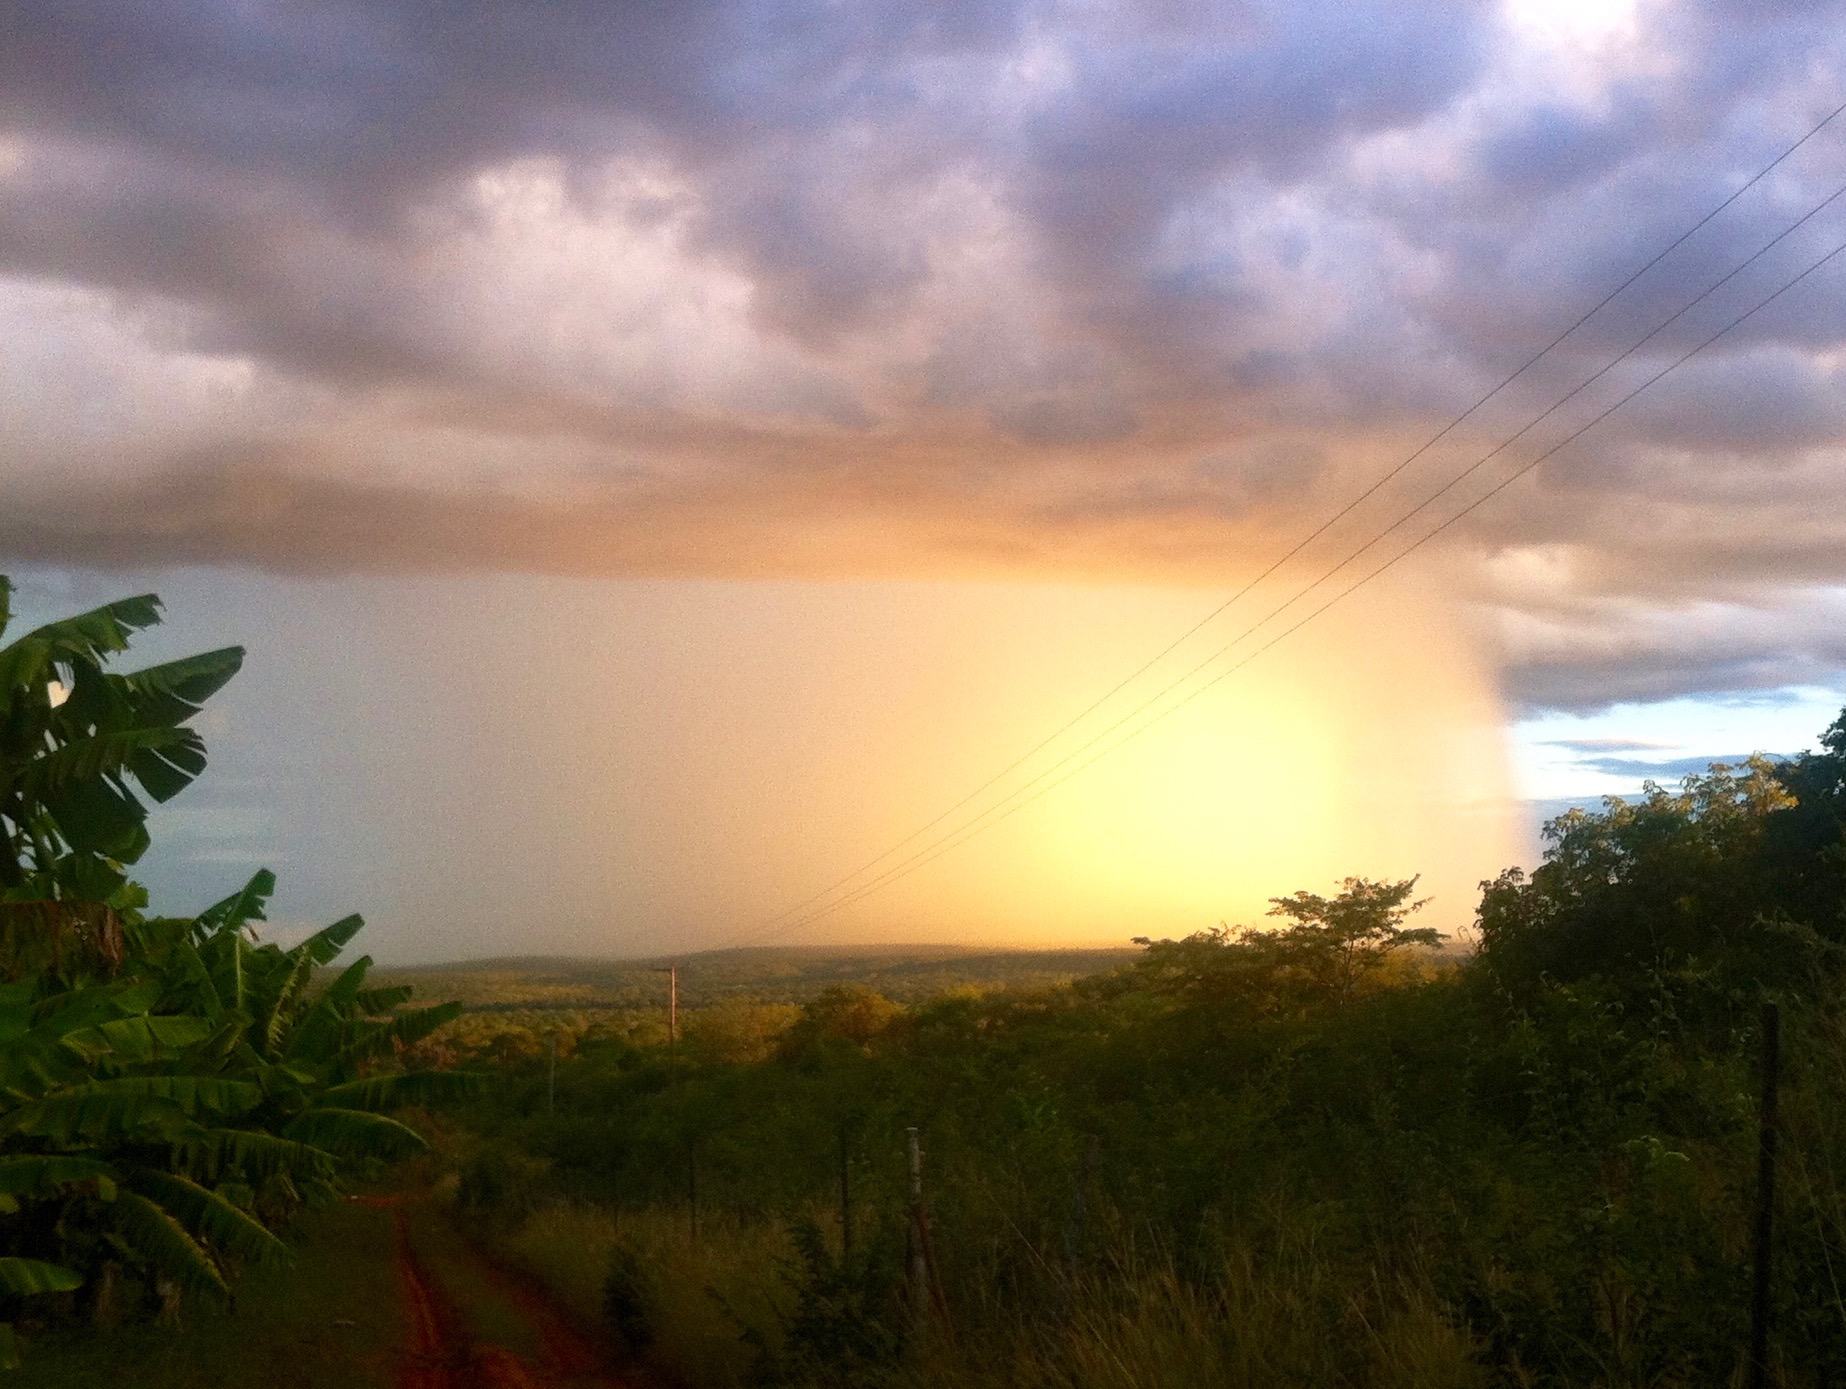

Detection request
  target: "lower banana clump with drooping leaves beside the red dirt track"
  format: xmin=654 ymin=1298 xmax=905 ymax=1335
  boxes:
xmin=0 ymin=872 xmax=478 ymax=1365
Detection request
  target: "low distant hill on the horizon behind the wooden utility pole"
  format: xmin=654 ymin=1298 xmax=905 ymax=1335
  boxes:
xmin=373 ymin=946 xmax=1141 ymax=1012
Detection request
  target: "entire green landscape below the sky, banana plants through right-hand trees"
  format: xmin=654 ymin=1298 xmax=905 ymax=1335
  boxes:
xmin=0 ymin=580 xmax=1846 ymax=1389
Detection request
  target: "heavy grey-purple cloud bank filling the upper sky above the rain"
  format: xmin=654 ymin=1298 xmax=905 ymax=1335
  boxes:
xmin=0 ymin=0 xmax=1846 ymax=707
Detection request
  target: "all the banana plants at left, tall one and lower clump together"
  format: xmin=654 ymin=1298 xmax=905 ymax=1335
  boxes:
xmin=0 ymin=578 xmax=465 ymax=1354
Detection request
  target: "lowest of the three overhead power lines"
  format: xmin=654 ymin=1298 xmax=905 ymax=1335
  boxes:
xmin=756 ymin=228 xmax=1846 ymax=931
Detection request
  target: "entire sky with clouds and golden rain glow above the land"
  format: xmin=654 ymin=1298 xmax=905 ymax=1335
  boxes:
xmin=0 ymin=0 xmax=1846 ymax=959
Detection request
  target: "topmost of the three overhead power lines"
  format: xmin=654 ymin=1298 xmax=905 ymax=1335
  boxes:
xmin=727 ymin=102 xmax=1846 ymax=927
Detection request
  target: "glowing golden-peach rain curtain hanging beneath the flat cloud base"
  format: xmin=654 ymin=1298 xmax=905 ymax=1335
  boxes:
xmin=325 ymin=565 xmax=1525 ymax=953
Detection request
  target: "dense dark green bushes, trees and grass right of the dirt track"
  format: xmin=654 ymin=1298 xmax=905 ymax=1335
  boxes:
xmin=445 ymin=738 xmax=1846 ymax=1389
